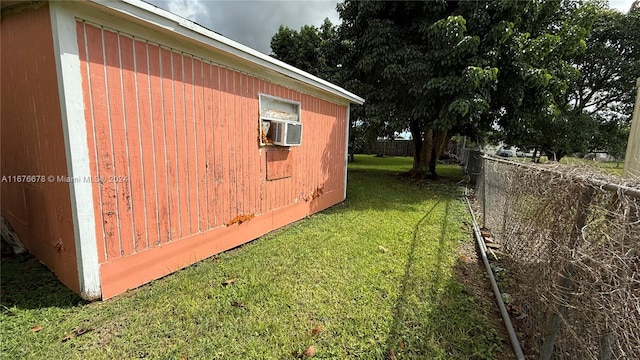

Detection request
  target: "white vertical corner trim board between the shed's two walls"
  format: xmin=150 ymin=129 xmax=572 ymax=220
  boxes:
xmin=49 ymin=2 xmax=102 ymax=300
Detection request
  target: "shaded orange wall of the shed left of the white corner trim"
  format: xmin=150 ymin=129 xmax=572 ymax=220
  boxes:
xmin=0 ymin=3 xmax=80 ymax=292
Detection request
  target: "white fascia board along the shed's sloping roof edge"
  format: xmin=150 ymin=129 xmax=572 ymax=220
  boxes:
xmin=89 ymin=0 xmax=364 ymax=105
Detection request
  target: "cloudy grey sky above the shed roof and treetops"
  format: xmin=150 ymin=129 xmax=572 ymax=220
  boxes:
xmin=146 ymin=0 xmax=633 ymax=54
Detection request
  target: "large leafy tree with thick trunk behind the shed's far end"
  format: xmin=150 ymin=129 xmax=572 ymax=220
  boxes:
xmin=338 ymin=0 xmax=589 ymax=175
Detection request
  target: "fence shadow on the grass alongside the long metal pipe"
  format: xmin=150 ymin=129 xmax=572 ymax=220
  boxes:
xmin=386 ymin=197 xmax=502 ymax=359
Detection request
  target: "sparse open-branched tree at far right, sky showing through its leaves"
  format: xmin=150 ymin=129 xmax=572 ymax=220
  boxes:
xmin=559 ymin=7 xmax=640 ymax=158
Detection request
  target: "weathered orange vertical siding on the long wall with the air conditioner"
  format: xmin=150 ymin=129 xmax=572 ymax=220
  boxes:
xmin=77 ymin=21 xmax=346 ymax=262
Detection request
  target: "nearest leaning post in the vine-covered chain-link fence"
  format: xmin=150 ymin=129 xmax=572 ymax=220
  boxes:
xmin=540 ymin=185 xmax=595 ymax=360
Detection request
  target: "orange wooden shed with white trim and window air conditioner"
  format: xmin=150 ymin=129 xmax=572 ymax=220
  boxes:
xmin=0 ymin=0 xmax=363 ymax=299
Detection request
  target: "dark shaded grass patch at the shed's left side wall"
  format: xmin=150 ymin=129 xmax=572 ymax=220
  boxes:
xmin=0 ymin=255 xmax=88 ymax=315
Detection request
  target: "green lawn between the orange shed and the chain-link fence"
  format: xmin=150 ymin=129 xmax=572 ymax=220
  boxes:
xmin=0 ymin=156 xmax=501 ymax=359
